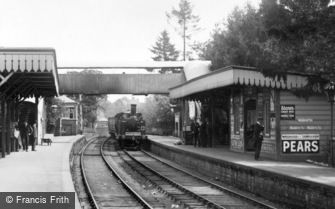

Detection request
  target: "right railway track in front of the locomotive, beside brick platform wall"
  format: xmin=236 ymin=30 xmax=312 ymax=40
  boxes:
xmin=119 ymin=151 xmax=275 ymax=209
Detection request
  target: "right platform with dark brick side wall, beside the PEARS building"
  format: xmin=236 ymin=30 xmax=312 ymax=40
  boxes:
xmin=148 ymin=135 xmax=335 ymax=209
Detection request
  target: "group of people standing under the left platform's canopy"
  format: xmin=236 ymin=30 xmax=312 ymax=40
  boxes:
xmin=13 ymin=121 xmax=37 ymax=152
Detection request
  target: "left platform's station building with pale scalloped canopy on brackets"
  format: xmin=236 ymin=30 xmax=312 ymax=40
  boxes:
xmin=0 ymin=48 xmax=58 ymax=157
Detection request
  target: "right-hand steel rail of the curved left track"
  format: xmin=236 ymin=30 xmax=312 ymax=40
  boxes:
xmin=100 ymin=139 xmax=153 ymax=209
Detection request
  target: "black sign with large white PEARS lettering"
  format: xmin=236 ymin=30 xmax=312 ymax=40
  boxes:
xmin=281 ymin=134 xmax=320 ymax=153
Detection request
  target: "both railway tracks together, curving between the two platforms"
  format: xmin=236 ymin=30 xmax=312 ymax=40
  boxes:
xmin=80 ymin=138 xmax=280 ymax=209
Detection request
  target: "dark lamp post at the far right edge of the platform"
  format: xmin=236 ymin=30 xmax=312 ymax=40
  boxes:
xmin=325 ymin=81 xmax=335 ymax=167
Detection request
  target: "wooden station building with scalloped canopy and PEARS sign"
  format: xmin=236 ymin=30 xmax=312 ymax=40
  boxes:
xmin=170 ymin=66 xmax=331 ymax=161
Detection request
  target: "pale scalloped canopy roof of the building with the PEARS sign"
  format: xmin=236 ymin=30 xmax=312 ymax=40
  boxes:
xmin=169 ymin=66 xmax=308 ymax=99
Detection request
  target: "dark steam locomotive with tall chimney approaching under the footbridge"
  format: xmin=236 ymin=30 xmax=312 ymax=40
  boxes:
xmin=108 ymin=104 xmax=147 ymax=149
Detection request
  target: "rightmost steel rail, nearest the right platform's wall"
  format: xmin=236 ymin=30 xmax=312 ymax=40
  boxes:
xmin=141 ymin=150 xmax=277 ymax=209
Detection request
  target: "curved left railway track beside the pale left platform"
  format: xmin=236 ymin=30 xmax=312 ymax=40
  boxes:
xmin=80 ymin=138 xmax=153 ymax=209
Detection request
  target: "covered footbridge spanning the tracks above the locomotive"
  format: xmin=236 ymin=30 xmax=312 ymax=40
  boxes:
xmin=58 ymin=61 xmax=209 ymax=95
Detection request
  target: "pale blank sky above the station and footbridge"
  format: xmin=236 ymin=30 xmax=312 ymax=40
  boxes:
xmin=0 ymin=0 xmax=260 ymax=66
